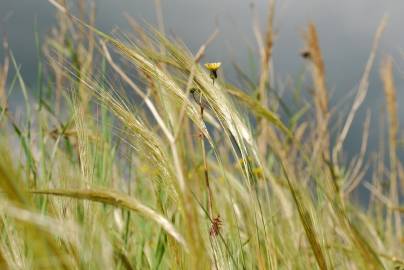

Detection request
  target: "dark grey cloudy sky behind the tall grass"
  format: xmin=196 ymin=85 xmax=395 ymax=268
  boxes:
xmin=0 ymin=0 xmax=404 ymax=180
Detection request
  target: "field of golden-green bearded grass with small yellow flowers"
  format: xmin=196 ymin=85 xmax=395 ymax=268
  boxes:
xmin=0 ymin=1 xmax=404 ymax=270
